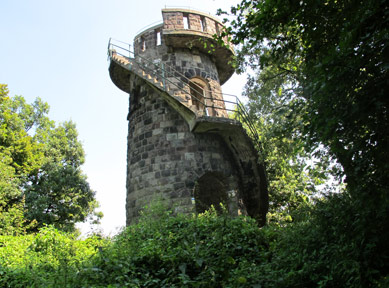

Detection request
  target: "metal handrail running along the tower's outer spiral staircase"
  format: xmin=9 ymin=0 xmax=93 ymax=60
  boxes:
xmin=108 ymin=38 xmax=262 ymax=150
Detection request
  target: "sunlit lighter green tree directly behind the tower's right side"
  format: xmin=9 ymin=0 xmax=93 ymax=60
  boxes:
xmin=229 ymin=42 xmax=339 ymax=224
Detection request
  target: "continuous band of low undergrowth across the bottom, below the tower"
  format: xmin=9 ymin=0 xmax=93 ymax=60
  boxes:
xmin=0 ymin=204 xmax=389 ymax=287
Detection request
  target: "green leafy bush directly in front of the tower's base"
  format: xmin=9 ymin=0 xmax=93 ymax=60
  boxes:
xmin=79 ymin=205 xmax=269 ymax=287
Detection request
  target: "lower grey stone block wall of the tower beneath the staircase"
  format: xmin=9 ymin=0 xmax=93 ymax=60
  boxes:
xmin=126 ymin=76 xmax=243 ymax=225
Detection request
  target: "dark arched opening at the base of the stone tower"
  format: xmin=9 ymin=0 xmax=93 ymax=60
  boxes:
xmin=193 ymin=172 xmax=228 ymax=213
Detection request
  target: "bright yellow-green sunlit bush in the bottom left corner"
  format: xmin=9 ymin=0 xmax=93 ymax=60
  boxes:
xmin=0 ymin=227 xmax=106 ymax=287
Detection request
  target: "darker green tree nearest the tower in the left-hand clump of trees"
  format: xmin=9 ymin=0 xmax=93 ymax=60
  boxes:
xmin=24 ymin=122 xmax=102 ymax=230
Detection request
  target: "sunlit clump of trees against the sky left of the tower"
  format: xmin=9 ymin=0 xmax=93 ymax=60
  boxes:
xmin=0 ymin=84 xmax=101 ymax=234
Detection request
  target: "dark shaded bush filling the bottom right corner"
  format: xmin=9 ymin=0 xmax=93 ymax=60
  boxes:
xmin=266 ymin=192 xmax=389 ymax=287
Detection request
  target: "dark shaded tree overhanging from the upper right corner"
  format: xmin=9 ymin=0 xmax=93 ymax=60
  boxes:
xmin=220 ymin=0 xmax=389 ymax=198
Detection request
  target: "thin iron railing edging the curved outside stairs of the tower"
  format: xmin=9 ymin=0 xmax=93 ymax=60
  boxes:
xmin=108 ymin=38 xmax=262 ymax=150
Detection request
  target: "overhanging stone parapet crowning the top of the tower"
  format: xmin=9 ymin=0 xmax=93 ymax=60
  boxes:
xmin=134 ymin=9 xmax=234 ymax=84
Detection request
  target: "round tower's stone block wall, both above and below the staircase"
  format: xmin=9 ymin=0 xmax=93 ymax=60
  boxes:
xmin=121 ymin=9 xmax=242 ymax=225
